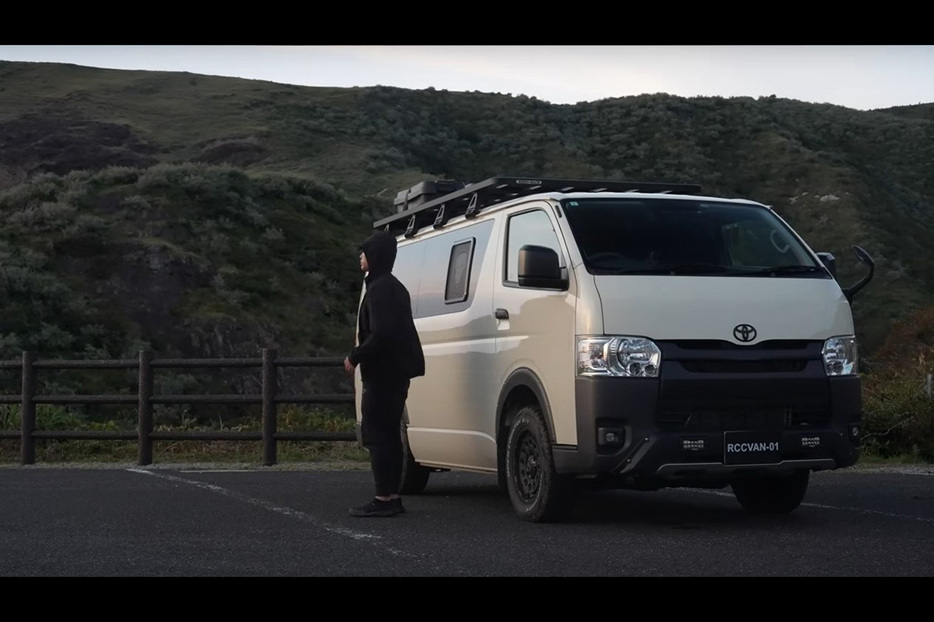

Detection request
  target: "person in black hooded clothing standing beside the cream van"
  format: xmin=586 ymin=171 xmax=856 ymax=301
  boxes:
xmin=344 ymin=231 xmax=425 ymax=517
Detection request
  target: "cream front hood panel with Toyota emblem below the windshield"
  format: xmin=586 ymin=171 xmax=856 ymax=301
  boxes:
xmin=589 ymin=275 xmax=853 ymax=345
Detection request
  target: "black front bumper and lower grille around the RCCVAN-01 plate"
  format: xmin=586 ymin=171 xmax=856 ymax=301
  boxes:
xmin=554 ymin=345 xmax=861 ymax=488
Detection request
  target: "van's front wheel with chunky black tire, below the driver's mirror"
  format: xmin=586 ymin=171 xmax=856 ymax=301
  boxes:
xmin=506 ymin=406 xmax=576 ymax=523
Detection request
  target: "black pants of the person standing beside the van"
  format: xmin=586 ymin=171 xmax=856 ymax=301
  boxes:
xmin=360 ymin=380 xmax=409 ymax=497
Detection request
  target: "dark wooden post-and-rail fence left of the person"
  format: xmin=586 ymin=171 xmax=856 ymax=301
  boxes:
xmin=0 ymin=349 xmax=356 ymax=466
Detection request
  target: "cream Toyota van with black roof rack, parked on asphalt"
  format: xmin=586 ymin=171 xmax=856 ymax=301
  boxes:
xmin=356 ymin=177 xmax=874 ymax=522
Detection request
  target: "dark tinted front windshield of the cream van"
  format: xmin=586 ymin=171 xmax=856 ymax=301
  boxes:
xmin=562 ymin=197 xmax=831 ymax=278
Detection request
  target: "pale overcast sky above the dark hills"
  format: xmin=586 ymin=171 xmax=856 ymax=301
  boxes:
xmin=0 ymin=45 xmax=934 ymax=110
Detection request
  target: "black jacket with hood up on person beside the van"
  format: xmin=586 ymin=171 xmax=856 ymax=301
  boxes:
xmin=349 ymin=231 xmax=425 ymax=384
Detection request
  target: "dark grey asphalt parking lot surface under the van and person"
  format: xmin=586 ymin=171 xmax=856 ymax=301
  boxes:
xmin=0 ymin=465 xmax=934 ymax=580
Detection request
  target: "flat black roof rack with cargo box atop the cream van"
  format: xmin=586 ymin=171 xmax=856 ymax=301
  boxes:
xmin=373 ymin=177 xmax=701 ymax=237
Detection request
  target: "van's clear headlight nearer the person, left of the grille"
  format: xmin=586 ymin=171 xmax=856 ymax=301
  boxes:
xmin=577 ymin=336 xmax=662 ymax=378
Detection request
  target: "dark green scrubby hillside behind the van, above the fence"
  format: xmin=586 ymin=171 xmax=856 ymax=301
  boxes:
xmin=0 ymin=62 xmax=934 ymax=394
